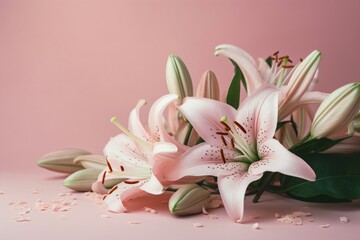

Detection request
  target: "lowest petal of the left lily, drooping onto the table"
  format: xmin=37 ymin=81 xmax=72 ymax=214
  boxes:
xmin=104 ymin=180 xmax=145 ymax=212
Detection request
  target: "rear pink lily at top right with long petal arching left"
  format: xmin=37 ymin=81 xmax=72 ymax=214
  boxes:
xmin=215 ymin=44 xmax=327 ymax=120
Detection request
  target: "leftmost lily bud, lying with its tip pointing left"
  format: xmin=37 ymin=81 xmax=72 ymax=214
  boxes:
xmin=36 ymin=149 xmax=90 ymax=173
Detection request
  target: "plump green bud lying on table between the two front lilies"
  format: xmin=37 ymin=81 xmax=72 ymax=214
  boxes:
xmin=169 ymin=184 xmax=210 ymax=216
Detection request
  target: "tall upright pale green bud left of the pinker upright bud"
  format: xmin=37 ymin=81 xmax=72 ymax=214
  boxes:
xmin=166 ymin=55 xmax=193 ymax=100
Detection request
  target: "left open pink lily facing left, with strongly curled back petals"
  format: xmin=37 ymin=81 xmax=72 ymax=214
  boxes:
xmin=92 ymin=94 xmax=186 ymax=212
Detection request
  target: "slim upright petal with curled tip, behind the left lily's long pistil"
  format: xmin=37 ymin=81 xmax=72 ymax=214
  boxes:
xmin=129 ymin=100 xmax=151 ymax=142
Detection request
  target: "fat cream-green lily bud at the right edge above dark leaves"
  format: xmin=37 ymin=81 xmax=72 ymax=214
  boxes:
xmin=310 ymin=83 xmax=360 ymax=138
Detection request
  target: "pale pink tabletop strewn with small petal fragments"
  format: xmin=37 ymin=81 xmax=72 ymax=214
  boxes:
xmin=0 ymin=170 xmax=360 ymax=240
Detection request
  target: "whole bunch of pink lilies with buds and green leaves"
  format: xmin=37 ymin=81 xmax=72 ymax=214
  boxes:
xmin=37 ymin=45 xmax=360 ymax=222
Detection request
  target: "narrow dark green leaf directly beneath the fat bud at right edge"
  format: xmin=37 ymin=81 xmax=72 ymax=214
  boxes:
xmin=289 ymin=138 xmax=344 ymax=154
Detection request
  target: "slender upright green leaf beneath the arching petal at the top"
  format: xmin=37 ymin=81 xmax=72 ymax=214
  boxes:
xmin=226 ymin=59 xmax=247 ymax=109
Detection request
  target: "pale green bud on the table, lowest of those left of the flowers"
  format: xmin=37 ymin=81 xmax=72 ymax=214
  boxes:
xmin=63 ymin=168 xmax=122 ymax=192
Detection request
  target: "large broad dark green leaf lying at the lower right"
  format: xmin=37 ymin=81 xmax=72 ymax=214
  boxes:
xmin=281 ymin=153 xmax=360 ymax=202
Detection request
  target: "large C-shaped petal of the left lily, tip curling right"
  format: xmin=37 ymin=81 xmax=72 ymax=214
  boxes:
xmin=149 ymin=94 xmax=187 ymax=152
